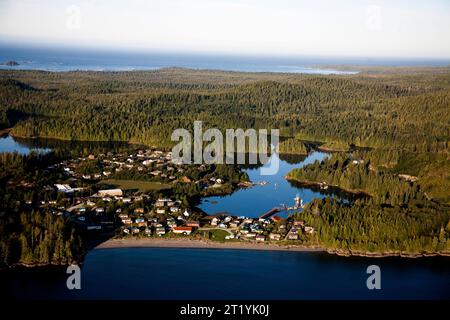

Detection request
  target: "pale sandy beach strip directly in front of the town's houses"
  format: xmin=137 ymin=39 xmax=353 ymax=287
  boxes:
xmin=94 ymin=238 xmax=324 ymax=252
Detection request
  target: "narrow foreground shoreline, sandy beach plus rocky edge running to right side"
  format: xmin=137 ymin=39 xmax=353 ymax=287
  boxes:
xmin=93 ymin=238 xmax=450 ymax=258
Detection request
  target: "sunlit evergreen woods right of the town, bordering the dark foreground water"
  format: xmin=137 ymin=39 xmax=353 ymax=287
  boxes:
xmin=296 ymin=198 xmax=450 ymax=254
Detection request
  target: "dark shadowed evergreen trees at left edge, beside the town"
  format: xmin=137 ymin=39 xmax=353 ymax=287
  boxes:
xmin=0 ymin=153 xmax=83 ymax=267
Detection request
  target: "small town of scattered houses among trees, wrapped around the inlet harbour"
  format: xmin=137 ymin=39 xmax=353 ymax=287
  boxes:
xmin=21 ymin=149 xmax=314 ymax=242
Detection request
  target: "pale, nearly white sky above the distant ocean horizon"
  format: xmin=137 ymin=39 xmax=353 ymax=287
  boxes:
xmin=0 ymin=0 xmax=450 ymax=58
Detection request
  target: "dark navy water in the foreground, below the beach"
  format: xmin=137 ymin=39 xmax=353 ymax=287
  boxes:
xmin=0 ymin=248 xmax=450 ymax=300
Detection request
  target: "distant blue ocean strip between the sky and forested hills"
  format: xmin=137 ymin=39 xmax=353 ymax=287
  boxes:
xmin=0 ymin=42 xmax=450 ymax=74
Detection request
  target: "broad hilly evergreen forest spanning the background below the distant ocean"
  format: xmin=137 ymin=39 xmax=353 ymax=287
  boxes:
xmin=0 ymin=69 xmax=450 ymax=152
